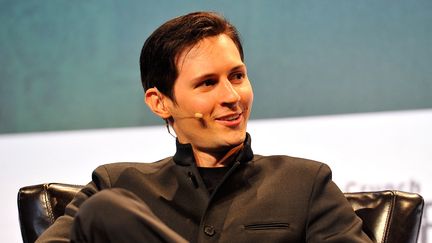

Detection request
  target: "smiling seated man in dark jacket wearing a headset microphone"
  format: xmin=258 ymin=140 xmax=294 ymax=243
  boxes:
xmin=38 ymin=12 xmax=370 ymax=242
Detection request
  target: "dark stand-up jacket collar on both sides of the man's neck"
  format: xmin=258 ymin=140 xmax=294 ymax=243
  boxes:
xmin=173 ymin=133 xmax=253 ymax=165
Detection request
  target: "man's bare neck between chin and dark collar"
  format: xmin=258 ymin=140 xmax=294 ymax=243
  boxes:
xmin=193 ymin=143 xmax=243 ymax=167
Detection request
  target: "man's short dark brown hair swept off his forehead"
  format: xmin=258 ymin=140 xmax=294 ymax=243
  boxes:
xmin=140 ymin=12 xmax=244 ymax=101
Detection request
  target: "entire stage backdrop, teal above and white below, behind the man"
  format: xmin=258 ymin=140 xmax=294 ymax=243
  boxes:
xmin=0 ymin=0 xmax=432 ymax=243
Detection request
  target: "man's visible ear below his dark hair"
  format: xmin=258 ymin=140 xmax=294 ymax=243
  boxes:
xmin=144 ymin=88 xmax=171 ymax=119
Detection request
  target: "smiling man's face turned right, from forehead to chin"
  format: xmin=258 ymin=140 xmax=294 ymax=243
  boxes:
xmin=168 ymin=34 xmax=253 ymax=152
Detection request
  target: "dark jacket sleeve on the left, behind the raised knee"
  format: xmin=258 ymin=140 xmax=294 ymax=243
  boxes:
xmin=36 ymin=166 xmax=110 ymax=243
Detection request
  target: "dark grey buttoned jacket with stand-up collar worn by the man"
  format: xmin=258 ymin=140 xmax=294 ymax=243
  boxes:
xmin=39 ymin=136 xmax=371 ymax=243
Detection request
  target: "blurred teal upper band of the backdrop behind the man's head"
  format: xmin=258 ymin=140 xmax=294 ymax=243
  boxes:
xmin=0 ymin=0 xmax=432 ymax=133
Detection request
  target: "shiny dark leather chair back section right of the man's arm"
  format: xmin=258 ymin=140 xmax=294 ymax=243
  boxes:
xmin=345 ymin=191 xmax=424 ymax=243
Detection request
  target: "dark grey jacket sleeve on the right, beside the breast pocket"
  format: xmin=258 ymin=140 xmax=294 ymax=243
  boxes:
xmin=306 ymin=164 xmax=372 ymax=243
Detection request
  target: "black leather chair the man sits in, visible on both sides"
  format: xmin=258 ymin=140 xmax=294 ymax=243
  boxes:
xmin=18 ymin=183 xmax=424 ymax=243
